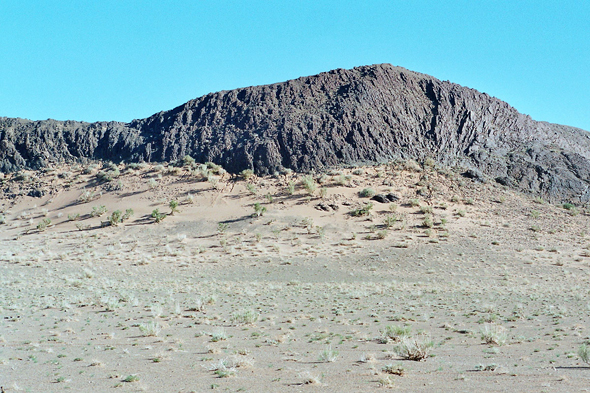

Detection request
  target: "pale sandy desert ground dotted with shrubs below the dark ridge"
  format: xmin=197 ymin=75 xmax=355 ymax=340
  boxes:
xmin=0 ymin=159 xmax=590 ymax=392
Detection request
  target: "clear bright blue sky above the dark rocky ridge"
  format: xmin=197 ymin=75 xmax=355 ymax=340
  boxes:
xmin=0 ymin=0 xmax=590 ymax=130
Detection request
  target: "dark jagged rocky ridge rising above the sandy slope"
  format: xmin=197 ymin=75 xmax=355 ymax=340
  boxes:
xmin=0 ymin=64 xmax=590 ymax=203
